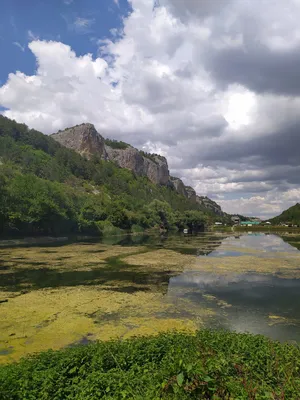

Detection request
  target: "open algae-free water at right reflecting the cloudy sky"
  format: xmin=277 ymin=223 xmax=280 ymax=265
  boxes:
xmin=168 ymin=234 xmax=300 ymax=342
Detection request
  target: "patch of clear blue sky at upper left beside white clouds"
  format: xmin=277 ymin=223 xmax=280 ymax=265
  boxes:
xmin=0 ymin=0 xmax=130 ymax=84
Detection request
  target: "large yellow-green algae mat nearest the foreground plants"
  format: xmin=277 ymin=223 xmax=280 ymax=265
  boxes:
xmin=0 ymin=287 xmax=209 ymax=362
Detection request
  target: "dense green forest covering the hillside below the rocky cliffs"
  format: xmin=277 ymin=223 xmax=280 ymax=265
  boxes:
xmin=0 ymin=116 xmax=230 ymax=235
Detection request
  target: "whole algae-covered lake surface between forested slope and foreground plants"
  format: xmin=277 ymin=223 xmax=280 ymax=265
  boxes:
xmin=0 ymin=233 xmax=300 ymax=362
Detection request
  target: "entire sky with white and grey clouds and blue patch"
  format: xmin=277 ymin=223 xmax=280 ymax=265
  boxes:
xmin=0 ymin=0 xmax=300 ymax=219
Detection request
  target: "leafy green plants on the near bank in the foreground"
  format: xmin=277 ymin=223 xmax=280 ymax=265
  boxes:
xmin=0 ymin=330 xmax=300 ymax=400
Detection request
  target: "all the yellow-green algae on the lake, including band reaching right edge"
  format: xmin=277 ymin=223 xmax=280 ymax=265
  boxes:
xmin=0 ymin=241 xmax=300 ymax=362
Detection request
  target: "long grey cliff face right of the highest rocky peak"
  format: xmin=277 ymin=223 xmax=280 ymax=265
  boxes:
xmin=105 ymin=146 xmax=170 ymax=185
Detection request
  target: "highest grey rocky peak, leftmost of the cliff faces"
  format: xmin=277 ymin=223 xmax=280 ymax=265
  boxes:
xmin=52 ymin=124 xmax=107 ymax=159
